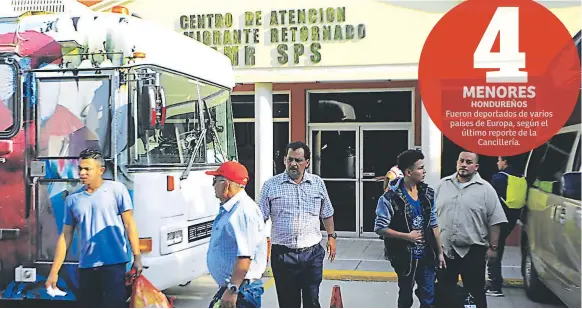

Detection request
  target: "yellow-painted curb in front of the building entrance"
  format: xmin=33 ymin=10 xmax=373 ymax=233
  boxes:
xmin=263 ymin=267 xmax=523 ymax=288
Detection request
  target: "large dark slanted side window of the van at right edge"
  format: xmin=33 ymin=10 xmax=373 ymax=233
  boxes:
xmin=537 ymin=132 xmax=578 ymax=193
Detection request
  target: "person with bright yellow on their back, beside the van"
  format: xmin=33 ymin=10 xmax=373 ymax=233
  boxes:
xmin=486 ymin=157 xmax=527 ymax=297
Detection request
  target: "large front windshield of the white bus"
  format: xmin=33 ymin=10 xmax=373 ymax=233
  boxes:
xmin=131 ymin=68 xmax=236 ymax=166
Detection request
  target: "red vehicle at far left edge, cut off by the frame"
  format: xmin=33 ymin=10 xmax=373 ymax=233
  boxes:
xmin=0 ymin=15 xmax=74 ymax=304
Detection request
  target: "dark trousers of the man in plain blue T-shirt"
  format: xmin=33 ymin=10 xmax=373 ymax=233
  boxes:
xmin=79 ymin=263 xmax=129 ymax=308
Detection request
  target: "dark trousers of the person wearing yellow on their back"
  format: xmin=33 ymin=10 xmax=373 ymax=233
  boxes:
xmin=487 ymin=207 xmax=521 ymax=291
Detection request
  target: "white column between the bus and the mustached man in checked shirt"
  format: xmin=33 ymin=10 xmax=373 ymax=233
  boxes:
xmin=255 ymin=83 xmax=273 ymax=201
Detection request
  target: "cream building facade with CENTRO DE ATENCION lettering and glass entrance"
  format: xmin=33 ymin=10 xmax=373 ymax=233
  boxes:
xmin=85 ymin=0 xmax=580 ymax=237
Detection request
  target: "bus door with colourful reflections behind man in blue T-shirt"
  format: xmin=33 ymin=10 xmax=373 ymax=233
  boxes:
xmin=30 ymin=70 xmax=119 ymax=277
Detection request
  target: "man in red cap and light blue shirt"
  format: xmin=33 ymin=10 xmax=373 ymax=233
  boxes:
xmin=206 ymin=161 xmax=267 ymax=308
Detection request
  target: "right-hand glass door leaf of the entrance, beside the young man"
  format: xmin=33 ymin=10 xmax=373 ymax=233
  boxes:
xmin=358 ymin=125 xmax=413 ymax=237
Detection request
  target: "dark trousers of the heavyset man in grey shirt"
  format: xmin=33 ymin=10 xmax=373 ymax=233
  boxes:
xmin=439 ymin=245 xmax=487 ymax=308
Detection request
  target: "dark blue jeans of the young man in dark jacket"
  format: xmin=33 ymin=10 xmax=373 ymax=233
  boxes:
xmin=397 ymin=255 xmax=436 ymax=308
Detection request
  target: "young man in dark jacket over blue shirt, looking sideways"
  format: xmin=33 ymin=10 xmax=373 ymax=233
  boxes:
xmin=374 ymin=150 xmax=445 ymax=308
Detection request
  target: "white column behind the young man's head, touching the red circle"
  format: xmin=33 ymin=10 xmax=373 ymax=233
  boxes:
xmin=421 ymin=104 xmax=442 ymax=188
